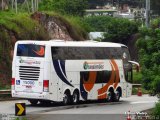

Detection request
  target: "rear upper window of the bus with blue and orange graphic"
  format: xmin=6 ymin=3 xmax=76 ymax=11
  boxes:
xmin=17 ymin=44 xmax=45 ymax=57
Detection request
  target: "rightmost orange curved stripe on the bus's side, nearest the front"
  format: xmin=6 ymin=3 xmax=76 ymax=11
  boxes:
xmin=111 ymin=60 xmax=120 ymax=88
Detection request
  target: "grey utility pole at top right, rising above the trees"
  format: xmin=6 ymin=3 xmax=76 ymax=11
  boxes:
xmin=146 ymin=0 xmax=150 ymax=28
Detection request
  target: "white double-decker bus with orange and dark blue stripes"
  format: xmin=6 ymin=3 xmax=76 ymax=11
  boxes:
xmin=12 ymin=40 xmax=139 ymax=105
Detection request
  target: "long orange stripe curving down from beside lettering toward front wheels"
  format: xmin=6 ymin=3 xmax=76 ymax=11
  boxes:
xmin=98 ymin=63 xmax=115 ymax=95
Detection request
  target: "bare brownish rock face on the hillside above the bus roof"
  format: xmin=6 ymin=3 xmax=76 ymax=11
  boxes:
xmin=31 ymin=12 xmax=84 ymax=41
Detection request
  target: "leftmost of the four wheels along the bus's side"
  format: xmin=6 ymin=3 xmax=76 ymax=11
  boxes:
xmin=63 ymin=89 xmax=71 ymax=105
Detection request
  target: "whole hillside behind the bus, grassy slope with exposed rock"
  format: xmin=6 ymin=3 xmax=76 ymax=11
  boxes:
xmin=0 ymin=12 xmax=87 ymax=88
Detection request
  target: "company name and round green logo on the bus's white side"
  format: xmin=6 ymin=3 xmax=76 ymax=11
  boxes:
xmin=83 ymin=61 xmax=104 ymax=70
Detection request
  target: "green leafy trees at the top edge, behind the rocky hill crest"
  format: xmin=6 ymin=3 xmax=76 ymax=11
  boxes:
xmin=40 ymin=0 xmax=88 ymax=16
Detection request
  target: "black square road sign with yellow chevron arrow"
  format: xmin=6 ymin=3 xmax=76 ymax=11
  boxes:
xmin=15 ymin=103 xmax=26 ymax=116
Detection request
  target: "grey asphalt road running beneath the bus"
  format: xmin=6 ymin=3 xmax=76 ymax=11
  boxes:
xmin=0 ymin=95 xmax=158 ymax=120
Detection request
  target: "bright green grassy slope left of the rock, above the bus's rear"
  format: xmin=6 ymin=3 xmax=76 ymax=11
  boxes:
xmin=0 ymin=12 xmax=47 ymax=40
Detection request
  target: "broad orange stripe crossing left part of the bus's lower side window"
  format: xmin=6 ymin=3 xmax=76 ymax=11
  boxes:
xmin=83 ymin=71 xmax=97 ymax=92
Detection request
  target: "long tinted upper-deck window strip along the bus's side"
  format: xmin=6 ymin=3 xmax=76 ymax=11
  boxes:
xmin=51 ymin=47 xmax=122 ymax=60
